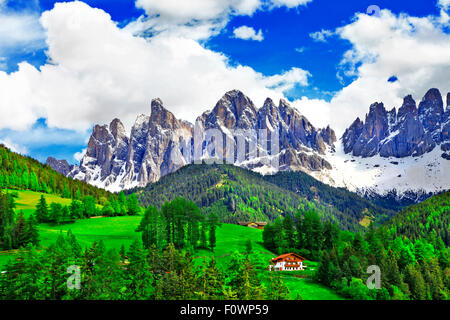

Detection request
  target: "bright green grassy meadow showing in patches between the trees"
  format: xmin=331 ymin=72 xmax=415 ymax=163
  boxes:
xmin=0 ymin=191 xmax=342 ymax=300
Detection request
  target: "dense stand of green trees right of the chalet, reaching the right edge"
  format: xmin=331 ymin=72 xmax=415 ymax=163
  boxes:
xmin=263 ymin=211 xmax=450 ymax=300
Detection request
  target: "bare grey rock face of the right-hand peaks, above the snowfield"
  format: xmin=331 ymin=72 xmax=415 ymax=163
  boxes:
xmin=342 ymin=89 xmax=450 ymax=158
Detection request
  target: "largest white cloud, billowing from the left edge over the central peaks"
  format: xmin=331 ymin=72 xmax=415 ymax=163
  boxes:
xmin=0 ymin=2 xmax=309 ymax=131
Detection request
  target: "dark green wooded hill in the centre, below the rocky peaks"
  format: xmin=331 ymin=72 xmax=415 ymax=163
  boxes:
xmin=126 ymin=164 xmax=394 ymax=230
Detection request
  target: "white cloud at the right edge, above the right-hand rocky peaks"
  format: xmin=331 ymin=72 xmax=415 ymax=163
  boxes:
xmin=298 ymin=10 xmax=450 ymax=135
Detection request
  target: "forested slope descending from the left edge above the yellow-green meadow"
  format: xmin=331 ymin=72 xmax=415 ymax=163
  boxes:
xmin=0 ymin=145 xmax=112 ymax=203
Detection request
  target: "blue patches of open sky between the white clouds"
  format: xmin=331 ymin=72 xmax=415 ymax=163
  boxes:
xmin=0 ymin=0 xmax=450 ymax=163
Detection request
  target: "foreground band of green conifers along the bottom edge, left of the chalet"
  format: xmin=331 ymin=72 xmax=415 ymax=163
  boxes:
xmin=0 ymin=231 xmax=289 ymax=300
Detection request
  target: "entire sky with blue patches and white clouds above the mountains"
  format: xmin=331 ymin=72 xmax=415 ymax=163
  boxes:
xmin=0 ymin=0 xmax=450 ymax=163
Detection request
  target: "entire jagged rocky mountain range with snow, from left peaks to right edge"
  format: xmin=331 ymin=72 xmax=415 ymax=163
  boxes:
xmin=49 ymin=89 xmax=450 ymax=204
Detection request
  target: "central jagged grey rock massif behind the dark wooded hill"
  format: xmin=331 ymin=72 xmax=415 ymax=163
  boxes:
xmin=51 ymin=90 xmax=336 ymax=191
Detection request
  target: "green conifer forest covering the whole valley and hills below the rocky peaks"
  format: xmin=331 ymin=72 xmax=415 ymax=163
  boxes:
xmin=0 ymin=148 xmax=450 ymax=300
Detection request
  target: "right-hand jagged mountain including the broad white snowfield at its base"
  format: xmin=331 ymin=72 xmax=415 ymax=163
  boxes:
xmin=312 ymin=89 xmax=450 ymax=201
